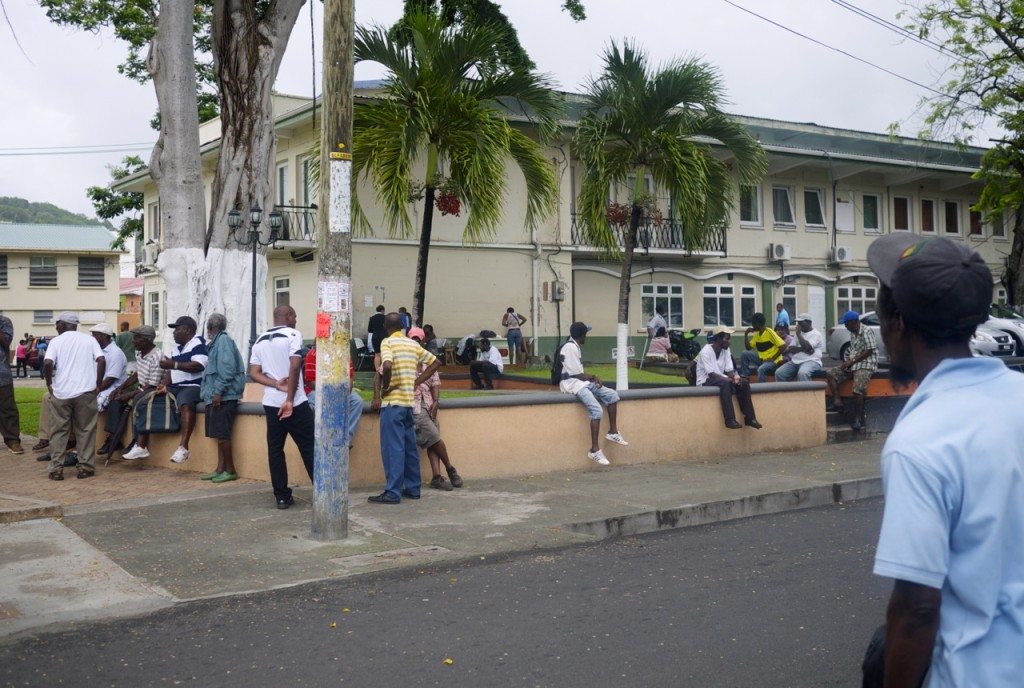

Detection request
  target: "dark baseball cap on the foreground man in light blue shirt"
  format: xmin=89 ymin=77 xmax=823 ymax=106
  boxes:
xmin=867 ymin=234 xmax=992 ymax=337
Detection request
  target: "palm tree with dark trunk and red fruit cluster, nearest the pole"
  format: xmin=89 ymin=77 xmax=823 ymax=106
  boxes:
xmin=352 ymin=13 xmax=561 ymax=325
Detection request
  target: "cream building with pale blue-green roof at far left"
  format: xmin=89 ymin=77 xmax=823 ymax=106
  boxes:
xmin=0 ymin=222 xmax=123 ymax=339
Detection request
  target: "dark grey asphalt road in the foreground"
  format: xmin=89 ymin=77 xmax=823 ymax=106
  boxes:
xmin=0 ymin=500 xmax=889 ymax=687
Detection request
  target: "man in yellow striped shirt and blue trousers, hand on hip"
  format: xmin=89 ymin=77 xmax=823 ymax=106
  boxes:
xmin=369 ymin=313 xmax=440 ymax=504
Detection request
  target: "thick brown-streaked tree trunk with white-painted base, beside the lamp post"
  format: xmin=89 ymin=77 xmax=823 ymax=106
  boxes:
xmin=201 ymin=0 xmax=305 ymax=342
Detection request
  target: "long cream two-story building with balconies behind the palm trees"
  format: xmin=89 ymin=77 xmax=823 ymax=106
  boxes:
xmin=117 ymin=83 xmax=1013 ymax=360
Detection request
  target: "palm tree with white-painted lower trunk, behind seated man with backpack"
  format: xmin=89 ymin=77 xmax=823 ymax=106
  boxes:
xmin=573 ymin=41 xmax=766 ymax=389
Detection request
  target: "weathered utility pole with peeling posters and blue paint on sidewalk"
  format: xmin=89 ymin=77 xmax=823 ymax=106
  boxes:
xmin=311 ymin=0 xmax=355 ymax=541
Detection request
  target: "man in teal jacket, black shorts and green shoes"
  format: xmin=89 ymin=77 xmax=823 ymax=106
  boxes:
xmin=200 ymin=313 xmax=246 ymax=482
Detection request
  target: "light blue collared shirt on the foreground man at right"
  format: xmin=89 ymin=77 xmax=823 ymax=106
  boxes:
xmin=874 ymin=357 xmax=1024 ymax=688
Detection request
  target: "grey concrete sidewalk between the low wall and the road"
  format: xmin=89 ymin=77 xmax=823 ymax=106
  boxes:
xmin=0 ymin=439 xmax=883 ymax=637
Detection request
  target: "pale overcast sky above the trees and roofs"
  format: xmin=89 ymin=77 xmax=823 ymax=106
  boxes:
xmin=0 ymin=0 xmax=987 ymax=216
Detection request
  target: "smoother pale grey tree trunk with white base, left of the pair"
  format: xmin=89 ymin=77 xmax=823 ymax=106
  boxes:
xmin=147 ymin=0 xmax=206 ymax=346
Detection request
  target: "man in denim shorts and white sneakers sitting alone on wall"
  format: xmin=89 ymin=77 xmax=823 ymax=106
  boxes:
xmin=555 ymin=323 xmax=629 ymax=466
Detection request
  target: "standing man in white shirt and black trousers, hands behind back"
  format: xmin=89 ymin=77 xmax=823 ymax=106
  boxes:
xmin=249 ymin=306 xmax=314 ymax=509
